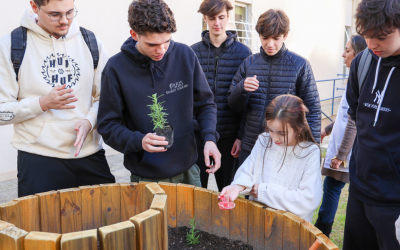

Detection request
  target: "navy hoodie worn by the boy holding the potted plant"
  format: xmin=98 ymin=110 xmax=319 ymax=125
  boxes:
xmin=98 ymin=38 xmax=218 ymax=179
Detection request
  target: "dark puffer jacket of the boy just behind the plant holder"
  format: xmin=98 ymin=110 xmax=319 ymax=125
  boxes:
xmin=191 ymin=30 xmax=251 ymax=139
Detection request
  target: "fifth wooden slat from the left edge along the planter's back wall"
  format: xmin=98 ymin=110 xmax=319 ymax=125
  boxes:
xmin=79 ymin=185 xmax=102 ymax=230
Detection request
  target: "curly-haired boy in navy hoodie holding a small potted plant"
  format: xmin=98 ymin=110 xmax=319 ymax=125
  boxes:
xmin=98 ymin=0 xmax=221 ymax=186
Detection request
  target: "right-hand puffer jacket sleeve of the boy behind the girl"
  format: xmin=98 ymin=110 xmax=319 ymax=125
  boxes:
xmin=297 ymin=61 xmax=321 ymax=143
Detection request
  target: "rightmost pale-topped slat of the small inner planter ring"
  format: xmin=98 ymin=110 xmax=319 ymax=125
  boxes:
xmin=150 ymin=194 xmax=168 ymax=250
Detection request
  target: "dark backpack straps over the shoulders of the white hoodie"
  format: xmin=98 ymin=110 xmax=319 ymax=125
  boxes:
xmin=11 ymin=26 xmax=99 ymax=82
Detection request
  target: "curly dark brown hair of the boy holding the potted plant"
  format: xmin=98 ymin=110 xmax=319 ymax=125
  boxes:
xmin=128 ymin=0 xmax=176 ymax=35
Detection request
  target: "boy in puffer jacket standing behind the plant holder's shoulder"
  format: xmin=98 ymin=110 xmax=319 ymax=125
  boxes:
xmin=192 ymin=0 xmax=251 ymax=190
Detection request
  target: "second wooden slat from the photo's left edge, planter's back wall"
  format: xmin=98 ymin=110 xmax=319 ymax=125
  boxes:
xmin=14 ymin=195 xmax=40 ymax=232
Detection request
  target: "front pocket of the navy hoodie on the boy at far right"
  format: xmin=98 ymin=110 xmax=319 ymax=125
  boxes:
xmin=354 ymin=143 xmax=400 ymax=202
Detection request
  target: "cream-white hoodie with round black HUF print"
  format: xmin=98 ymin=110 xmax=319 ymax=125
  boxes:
xmin=0 ymin=9 xmax=108 ymax=159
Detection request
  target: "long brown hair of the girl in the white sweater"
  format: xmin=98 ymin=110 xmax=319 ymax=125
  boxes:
xmin=264 ymin=94 xmax=318 ymax=172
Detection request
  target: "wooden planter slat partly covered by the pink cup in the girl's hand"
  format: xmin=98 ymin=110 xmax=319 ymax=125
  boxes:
xmin=211 ymin=192 xmax=231 ymax=238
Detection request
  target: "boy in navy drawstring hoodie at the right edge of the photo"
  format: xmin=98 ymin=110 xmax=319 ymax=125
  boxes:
xmin=343 ymin=0 xmax=400 ymax=250
